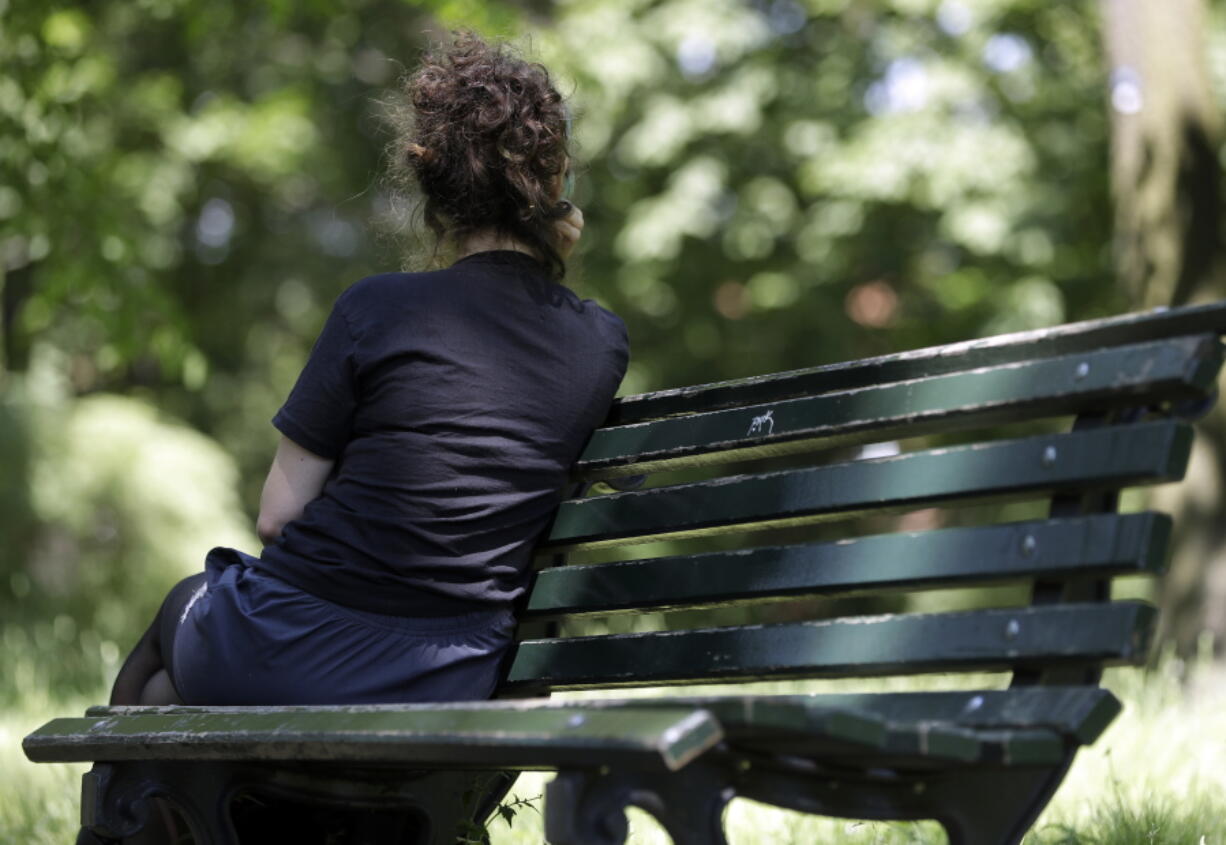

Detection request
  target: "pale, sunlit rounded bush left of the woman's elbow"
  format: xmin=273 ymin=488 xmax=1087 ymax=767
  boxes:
xmin=0 ymin=348 xmax=255 ymax=704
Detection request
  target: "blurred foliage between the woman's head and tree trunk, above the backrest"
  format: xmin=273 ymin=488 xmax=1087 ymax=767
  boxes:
xmin=541 ymin=0 xmax=1125 ymax=391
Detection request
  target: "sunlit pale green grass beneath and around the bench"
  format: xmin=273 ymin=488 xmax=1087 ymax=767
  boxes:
xmin=0 ymin=659 xmax=1226 ymax=845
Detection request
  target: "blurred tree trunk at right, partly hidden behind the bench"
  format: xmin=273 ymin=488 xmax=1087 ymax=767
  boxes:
xmin=1101 ymin=0 xmax=1226 ymax=654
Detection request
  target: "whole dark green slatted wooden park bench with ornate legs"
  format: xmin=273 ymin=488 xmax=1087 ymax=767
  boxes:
xmin=25 ymin=304 xmax=1226 ymax=845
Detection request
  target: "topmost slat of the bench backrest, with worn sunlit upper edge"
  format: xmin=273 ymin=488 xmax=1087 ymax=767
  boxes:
xmin=607 ymin=303 xmax=1226 ymax=426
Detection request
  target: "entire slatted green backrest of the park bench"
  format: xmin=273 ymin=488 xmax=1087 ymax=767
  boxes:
xmin=501 ymin=305 xmax=1226 ymax=694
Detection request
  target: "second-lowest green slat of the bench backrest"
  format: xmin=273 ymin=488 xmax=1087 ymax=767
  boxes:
xmin=522 ymin=513 xmax=1171 ymax=618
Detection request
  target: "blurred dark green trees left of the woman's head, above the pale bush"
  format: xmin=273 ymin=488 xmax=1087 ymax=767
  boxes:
xmin=0 ymin=0 xmax=517 ymax=507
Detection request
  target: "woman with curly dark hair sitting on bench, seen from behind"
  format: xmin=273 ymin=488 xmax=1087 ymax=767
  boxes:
xmin=102 ymin=33 xmax=628 ymax=705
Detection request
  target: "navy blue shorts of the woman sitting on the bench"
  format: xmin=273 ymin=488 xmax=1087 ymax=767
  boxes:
xmin=170 ymin=548 xmax=515 ymax=705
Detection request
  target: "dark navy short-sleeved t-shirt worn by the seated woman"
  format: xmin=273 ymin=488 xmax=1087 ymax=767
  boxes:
xmin=259 ymin=251 xmax=628 ymax=616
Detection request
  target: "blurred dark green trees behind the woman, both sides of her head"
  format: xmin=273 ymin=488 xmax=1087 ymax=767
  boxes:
xmin=9 ymin=0 xmax=1220 ymax=672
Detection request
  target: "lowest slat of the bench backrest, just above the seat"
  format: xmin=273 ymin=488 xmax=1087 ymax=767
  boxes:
xmin=506 ymin=602 xmax=1155 ymax=689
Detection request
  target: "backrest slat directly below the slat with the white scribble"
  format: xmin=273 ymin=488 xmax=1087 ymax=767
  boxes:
xmin=542 ymin=421 xmax=1192 ymax=551
